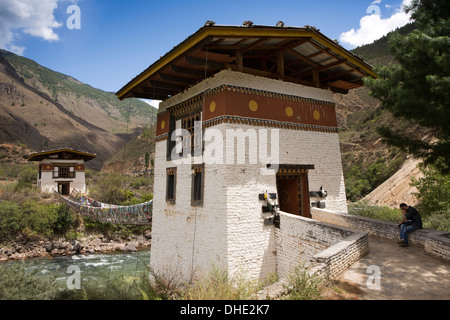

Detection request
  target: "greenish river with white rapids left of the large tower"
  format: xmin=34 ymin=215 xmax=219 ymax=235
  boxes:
xmin=2 ymin=249 xmax=150 ymax=298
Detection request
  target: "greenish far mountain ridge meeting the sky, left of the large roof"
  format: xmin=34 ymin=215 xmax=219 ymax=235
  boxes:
xmin=0 ymin=50 xmax=157 ymax=133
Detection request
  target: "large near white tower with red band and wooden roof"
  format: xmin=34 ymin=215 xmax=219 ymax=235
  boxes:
xmin=117 ymin=23 xmax=375 ymax=280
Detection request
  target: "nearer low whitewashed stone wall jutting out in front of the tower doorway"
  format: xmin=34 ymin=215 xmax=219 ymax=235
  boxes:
xmin=275 ymin=212 xmax=369 ymax=277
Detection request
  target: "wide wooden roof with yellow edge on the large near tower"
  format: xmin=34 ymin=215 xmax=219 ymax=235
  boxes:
xmin=116 ymin=23 xmax=376 ymax=100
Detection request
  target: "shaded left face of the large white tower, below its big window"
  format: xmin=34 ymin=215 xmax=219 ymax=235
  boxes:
xmin=150 ymin=140 xmax=227 ymax=280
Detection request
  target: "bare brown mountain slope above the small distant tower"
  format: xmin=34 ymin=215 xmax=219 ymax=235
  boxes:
xmin=0 ymin=56 xmax=121 ymax=170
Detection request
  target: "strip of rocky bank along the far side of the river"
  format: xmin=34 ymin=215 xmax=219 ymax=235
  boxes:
xmin=0 ymin=232 xmax=151 ymax=262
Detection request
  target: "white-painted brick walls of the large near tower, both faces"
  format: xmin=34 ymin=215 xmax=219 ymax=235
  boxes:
xmin=150 ymin=71 xmax=347 ymax=280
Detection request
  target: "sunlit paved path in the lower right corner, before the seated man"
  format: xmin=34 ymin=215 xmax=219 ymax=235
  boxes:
xmin=339 ymin=236 xmax=450 ymax=300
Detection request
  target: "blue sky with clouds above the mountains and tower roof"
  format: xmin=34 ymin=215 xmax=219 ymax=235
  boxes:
xmin=0 ymin=0 xmax=410 ymax=92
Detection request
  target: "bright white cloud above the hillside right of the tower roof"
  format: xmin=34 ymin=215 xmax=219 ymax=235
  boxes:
xmin=339 ymin=0 xmax=412 ymax=47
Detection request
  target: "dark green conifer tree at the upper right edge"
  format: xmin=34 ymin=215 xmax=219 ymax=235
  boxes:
xmin=365 ymin=0 xmax=450 ymax=172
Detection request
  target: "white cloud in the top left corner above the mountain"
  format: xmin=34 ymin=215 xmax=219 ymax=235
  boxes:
xmin=0 ymin=0 xmax=62 ymax=55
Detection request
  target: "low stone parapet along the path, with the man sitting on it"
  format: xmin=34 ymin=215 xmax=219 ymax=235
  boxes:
xmin=311 ymin=208 xmax=450 ymax=261
